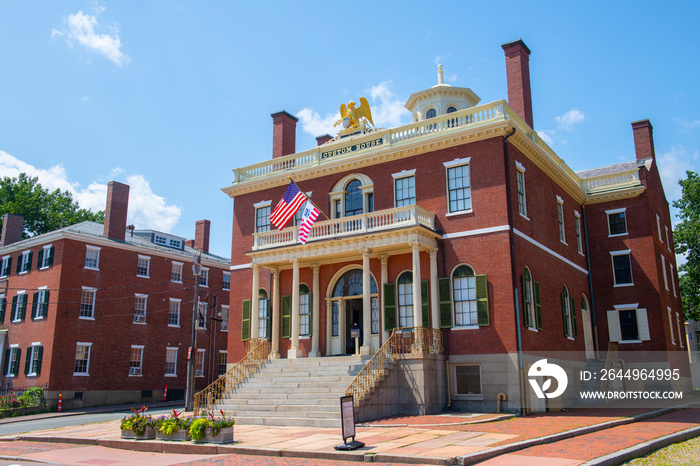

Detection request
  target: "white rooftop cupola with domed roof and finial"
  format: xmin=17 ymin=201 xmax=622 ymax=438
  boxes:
xmin=404 ymin=65 xmax=481 ymax=122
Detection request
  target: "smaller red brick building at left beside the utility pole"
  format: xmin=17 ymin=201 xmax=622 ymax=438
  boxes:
xmin=0 ymin=182 xmax=230 ymax=409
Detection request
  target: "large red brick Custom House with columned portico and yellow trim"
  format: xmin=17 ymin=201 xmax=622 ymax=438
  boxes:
xmin=224 ymin=41 xmax=688 ymax=411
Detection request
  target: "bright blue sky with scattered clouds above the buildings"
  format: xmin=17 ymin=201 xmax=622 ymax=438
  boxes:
xmin=0 ymin=0 xmax=700 ymax=256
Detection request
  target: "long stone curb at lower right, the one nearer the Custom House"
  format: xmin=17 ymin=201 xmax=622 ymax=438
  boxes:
xmin=457 ymin=405 xmax=689 ymax=466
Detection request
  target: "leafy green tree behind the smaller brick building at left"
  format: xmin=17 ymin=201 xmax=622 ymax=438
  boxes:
xmin=0 ymin=173 xmax=104 ymax=239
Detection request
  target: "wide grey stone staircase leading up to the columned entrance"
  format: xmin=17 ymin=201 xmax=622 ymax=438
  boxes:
xmin=213 ymin=356 xmax=370 ymax=427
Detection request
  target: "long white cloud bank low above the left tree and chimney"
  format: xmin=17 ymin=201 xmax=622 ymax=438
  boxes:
xmin=0 ymin=150 xmax=182 ymax=233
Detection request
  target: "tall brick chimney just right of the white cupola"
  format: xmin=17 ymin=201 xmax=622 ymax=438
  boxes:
xmin=501 ymin=39 xmax=534 ymax=128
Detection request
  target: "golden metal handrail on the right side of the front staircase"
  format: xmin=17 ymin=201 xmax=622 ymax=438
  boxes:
xmin=345 ymin=327 xmax=444 ymax=406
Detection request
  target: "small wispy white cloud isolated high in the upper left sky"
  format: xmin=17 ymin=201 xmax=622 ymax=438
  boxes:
xmin=51 ymin=7 xmax=129 ymax=66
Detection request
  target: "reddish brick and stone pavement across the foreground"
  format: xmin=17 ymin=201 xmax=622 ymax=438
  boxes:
xmin=0 ymin=404 xmax=700 ymax=466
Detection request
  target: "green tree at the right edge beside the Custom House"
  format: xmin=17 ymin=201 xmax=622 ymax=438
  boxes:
xmin=673 ymin=171 xmax=700 ymax=320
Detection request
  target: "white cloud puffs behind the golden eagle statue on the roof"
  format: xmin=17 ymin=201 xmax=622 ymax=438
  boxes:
xmin=297 ymin=80 xmax=410 ymax=137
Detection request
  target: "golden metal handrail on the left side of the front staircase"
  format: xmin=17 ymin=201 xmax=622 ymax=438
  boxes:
xmin=194 ymin=338 xmax=270 ymax=416
